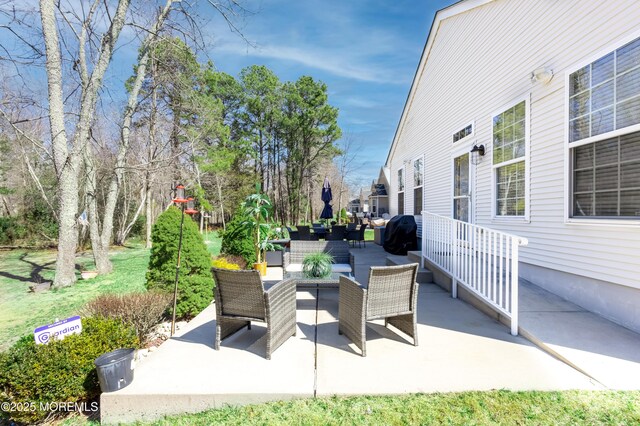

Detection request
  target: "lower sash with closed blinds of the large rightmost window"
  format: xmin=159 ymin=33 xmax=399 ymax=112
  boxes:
xmin=572 ymin=132 xmax=640 ymax=219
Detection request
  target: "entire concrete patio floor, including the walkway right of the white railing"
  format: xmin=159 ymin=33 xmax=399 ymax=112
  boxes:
xmin=101 ymin=244 xmax=640 ymax=423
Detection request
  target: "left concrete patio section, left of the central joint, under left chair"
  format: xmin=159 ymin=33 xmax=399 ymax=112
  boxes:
xmin=100 ymin=291 xmax=316 ymax=424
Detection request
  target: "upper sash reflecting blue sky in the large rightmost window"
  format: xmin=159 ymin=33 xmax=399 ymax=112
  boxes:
xmin=569 ymin=38 xmax=640 ymax=142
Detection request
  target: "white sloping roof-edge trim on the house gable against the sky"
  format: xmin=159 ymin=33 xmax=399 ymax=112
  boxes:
xmin=385 ymin=0 xmax=495 ymax=167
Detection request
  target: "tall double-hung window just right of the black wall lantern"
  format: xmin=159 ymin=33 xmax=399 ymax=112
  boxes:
xmin=493 ymin=101 xmax=527 ymax=217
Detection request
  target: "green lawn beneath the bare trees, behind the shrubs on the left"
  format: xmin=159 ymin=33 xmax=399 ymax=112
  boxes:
xmin=0 ymin=233 xmax=220 ymax=351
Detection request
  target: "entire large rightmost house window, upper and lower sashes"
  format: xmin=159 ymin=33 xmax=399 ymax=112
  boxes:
xmin=568 ymin=38 xmax=640 ymax=219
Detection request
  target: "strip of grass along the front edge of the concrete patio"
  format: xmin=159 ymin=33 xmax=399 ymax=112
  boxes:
xmin=60 ymin=391 xmax=640 ymax=425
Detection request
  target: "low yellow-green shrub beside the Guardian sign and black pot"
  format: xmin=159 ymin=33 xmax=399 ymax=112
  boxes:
xmin=0 ymin=318 xmax=138 ymax=423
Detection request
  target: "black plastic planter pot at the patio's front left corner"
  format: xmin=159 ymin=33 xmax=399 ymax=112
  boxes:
xmin=94 ymin=349 xmax=136 ymax=392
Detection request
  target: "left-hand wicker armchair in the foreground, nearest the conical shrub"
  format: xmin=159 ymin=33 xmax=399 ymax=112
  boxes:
xmin=212 ymin=268 xmax=296 ymax=359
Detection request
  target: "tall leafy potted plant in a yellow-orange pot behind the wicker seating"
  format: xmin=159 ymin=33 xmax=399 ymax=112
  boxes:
xmin=242 ymin=185 xmax=271 ymax=276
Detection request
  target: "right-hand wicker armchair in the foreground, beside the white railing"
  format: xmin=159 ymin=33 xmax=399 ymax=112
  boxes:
xmin=338 ymin=263 xmax=418 ymax=356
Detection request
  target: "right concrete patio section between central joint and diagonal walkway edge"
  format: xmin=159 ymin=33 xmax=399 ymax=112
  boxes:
xmin=316 ymin=284 xmax=602 ymax=396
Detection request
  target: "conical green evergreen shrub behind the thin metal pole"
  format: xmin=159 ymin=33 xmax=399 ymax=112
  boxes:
xmin=147 ymin=207 xmax=213 ymax=318
